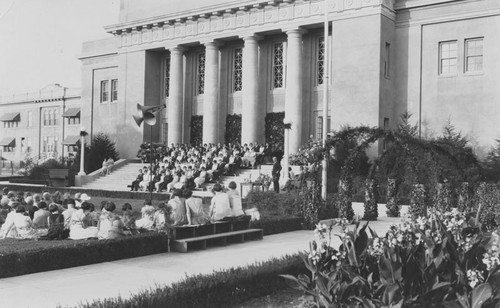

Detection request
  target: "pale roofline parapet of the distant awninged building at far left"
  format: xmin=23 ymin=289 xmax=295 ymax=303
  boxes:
xmin=0 ymin=84 xmax=82 ymax=104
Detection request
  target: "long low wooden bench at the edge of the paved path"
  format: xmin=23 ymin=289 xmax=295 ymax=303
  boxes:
xmin=170 ymin=229 xmax=264 ymax=253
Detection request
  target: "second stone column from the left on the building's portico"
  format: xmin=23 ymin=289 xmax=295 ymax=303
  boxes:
xmin=203 ymin=42 xmax=220 ymax=143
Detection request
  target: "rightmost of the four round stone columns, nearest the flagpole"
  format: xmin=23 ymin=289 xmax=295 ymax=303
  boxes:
xmin=285 ymin=29 xmax=304 ymax=153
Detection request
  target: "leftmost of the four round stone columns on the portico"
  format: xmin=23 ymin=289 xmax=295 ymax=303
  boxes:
xmin=167 ymin=46 xmax=185 ymax=144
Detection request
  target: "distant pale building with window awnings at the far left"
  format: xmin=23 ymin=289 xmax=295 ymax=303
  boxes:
xmin=0 ymin=85 xmax=80 ymax=166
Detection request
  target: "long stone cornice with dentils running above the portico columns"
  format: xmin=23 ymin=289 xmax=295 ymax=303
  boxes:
xmin=106 ymin=0 xmax=395 ymax=49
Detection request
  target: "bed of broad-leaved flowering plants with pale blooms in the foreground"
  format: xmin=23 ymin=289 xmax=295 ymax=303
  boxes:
xmin=284 ymin=212 xmax=500 ymax=308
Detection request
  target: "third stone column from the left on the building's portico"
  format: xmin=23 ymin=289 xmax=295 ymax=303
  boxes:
xmin=241 ymin=35 xmax=265 ymax=144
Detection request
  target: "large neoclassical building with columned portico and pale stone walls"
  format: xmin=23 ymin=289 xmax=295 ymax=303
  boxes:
xmin=80 ymin=0 xmax=500 ymax=157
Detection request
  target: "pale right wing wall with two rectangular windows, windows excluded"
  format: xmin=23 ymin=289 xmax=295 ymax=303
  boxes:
xmin=396 ymin=0 xmax=500 ymax=156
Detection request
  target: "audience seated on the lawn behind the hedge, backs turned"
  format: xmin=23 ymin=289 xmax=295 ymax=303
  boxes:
xmin=0 ymin=182 xmax=244 ymax=240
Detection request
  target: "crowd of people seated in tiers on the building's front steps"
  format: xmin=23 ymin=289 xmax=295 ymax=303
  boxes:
xmin=129 ymin=143 xmax=278 ymax=192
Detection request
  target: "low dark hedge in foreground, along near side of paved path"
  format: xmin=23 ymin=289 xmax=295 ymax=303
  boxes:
xmin=80 ymin=255 xmax=306 ymax=308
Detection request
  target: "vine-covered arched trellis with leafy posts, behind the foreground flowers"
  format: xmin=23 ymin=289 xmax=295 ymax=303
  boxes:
xmin=291 ymin=122 xmax=478 ymax=224
